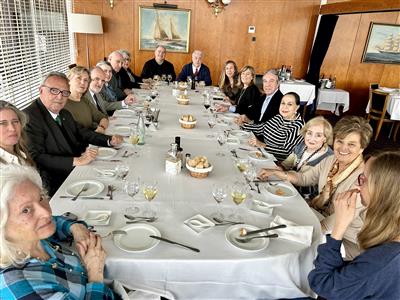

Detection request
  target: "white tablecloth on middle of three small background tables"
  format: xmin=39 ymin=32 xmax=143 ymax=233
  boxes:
xmin=317 ymin=89 xmax=350 ymax=115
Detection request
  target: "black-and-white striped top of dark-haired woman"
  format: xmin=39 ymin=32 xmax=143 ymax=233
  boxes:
xmin=243 ymin=114 xmax=304 ymax=161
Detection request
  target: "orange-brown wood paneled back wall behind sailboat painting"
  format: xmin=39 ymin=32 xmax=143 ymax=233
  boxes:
xmin=74 ymin=0 xmax=320 ymax=84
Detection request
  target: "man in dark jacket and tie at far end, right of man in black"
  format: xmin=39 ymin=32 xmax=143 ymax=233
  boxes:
xmin=178 ymin=50 xmax=212 ymax=85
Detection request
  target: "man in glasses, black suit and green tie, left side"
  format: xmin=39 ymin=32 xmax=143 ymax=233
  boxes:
xmin=25 ymin=72 xmax=122 ymax=195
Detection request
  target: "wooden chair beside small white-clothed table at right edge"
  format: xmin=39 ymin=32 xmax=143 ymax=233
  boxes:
xmin=367 ymin=85 xmax=398 ymax=141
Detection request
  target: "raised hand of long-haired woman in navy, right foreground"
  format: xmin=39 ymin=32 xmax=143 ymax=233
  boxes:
xmin=331 ymin=189 xmax=360 ymax=240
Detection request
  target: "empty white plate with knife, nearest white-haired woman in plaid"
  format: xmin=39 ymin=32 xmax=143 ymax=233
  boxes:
xmin=114 ymin=223 xmax=161 ymax=252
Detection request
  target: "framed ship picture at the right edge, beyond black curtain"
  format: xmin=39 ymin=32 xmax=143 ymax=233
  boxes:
xmin=362 ymin=22 xmax=400 ymax=64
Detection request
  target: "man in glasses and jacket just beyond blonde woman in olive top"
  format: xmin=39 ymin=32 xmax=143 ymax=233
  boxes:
xmin=82 ymin=67 xmax=135 ymax=115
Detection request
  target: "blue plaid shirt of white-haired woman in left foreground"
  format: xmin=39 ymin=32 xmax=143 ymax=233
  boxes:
xmin=0 ymin=216 xmax=114 ymax=300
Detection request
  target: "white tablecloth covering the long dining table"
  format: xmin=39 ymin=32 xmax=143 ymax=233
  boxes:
xmin=50 ymin=85 xmax=321 ymax=299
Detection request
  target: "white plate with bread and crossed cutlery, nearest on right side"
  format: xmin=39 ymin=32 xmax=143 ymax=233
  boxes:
xmin=225 ymin=224 xmax=269 ymax=251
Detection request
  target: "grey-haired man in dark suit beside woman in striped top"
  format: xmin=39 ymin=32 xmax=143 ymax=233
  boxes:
xmin=237 ymin=69 xmax=283 ymax=125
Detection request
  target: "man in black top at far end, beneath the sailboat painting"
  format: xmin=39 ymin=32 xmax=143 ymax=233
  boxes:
xmin=141 ymin=45 xmax=176 ymax=81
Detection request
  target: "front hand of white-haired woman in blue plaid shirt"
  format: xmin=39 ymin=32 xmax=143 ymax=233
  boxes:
xmin=76 ymin=232 xmax=106 ymax=282
